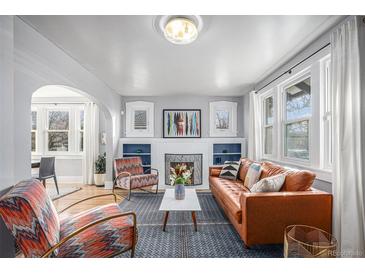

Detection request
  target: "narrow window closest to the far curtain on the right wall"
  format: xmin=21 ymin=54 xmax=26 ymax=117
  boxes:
xmin=264 ymin=96 xmax=274 ymax=155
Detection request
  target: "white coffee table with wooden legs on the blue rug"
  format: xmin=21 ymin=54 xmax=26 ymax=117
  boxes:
xmin=159 ymin=189 xmax=202 ymax=231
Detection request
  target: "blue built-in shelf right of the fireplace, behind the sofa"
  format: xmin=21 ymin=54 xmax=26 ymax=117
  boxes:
xmin=213 ymin=143 xmax=242 ymax=165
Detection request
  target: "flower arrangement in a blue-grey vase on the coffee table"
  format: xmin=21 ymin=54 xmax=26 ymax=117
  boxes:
xmin=170 ymin=164 xmax=192 ymax=200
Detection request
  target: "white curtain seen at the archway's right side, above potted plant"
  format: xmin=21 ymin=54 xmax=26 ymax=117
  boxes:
xmin=82 ymin=103 xmax=99 ymax=184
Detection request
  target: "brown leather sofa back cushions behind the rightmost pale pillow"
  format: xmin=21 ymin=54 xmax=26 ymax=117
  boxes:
xmin=260 ymin=162 xmax=316 ymax=191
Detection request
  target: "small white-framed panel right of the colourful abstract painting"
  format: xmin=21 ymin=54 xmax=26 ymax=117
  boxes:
xmin=209 ymin=101 xmax=237 ymax=137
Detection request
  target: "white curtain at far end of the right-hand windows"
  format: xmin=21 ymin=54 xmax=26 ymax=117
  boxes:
xmin=248 ymin=91 xmax=261 ymax=161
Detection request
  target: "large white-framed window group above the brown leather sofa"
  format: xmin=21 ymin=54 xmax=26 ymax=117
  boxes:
xmin=258 ymin=52 xmax=333 ymax=178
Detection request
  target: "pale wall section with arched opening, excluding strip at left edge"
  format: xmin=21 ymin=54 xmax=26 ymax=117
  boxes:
xmin=14 ymin=17 xmax=121 ymax=184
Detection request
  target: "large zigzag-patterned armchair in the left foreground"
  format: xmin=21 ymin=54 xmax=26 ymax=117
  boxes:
xmin=0 ymin=179 xmax=137 ymax=258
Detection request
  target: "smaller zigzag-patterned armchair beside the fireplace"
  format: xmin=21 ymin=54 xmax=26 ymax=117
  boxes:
xmin=113 ymin=157 xmax=158 ymax=200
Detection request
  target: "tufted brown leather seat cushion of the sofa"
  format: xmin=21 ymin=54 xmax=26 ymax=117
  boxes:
xmin=210 ymin=177 xmax=249 ymax=224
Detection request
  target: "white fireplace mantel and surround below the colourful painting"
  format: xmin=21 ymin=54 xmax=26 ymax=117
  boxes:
xmin=118 ymin=138 xmax=246 ymax=189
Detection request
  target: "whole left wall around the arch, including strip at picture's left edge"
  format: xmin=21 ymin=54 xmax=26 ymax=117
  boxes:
xmin=0 ymin=16 xmax=121 ymax=257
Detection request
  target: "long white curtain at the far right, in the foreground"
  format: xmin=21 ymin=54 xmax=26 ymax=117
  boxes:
xmin=331 ymin=17 xmax=365 ymax=257
